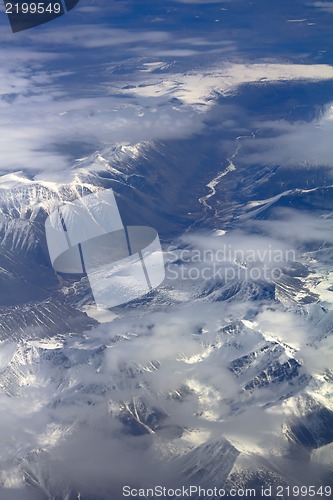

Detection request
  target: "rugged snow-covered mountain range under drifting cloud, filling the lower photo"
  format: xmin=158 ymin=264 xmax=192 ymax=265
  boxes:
xmin=0 ymin=126 xmax=333 ymax=500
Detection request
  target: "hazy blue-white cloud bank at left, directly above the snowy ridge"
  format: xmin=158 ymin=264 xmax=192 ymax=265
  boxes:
xmin=0 ymin=54 xmax=202 ymax=177
